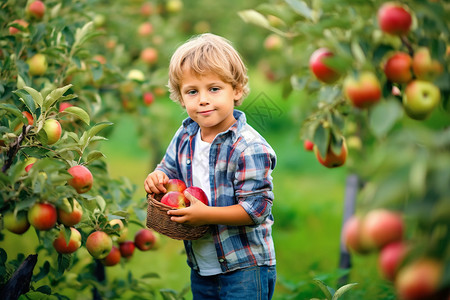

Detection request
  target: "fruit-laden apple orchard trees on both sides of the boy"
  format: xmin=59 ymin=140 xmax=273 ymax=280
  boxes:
xmin=0 ymin=0 xmax=450 ymax=300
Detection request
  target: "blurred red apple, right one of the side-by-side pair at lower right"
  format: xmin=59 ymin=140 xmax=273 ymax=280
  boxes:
xmin=360 ymin=208 xmax=403 ymax=250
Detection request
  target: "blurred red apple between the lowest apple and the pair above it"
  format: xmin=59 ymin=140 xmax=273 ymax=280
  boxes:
xmin=378 ymin=241 xmax=409 ymax=281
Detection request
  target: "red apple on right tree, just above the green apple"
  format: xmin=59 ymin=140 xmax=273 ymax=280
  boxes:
xmin=384 ymin=52 xmax=412 ymax=83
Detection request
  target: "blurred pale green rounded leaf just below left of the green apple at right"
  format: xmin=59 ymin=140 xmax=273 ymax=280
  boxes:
xmin=369 ymin=99 xmax=403 ymax=138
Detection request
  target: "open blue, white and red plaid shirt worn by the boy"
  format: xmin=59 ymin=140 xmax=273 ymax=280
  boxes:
xmin=157 ymin=110 xmax=276 ymax=272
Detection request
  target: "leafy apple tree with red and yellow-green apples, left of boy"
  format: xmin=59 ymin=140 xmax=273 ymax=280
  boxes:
xmin=0 ymin=1 xmax=174 ymax=299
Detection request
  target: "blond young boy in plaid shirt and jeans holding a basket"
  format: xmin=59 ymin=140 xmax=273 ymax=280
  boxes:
xmin=144 ymin=33 xmax=276 ymax=300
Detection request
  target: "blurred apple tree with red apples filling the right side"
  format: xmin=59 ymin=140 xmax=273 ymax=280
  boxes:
xmin=240 ymin=0 xmax=450 ymax=299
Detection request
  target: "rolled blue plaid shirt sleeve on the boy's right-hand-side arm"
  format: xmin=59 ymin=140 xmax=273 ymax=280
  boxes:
xmin=234 ymin=143 xmax=276 ymax=225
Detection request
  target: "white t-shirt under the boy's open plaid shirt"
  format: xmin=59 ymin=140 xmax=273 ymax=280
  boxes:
xmin=192 ymin=129 xmax=222 ymax=276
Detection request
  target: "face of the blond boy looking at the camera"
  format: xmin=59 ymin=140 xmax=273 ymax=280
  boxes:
xmin=180 ymin=67 xmax=242 ymax=142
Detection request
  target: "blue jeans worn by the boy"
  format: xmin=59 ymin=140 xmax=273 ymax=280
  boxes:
xmin=191 ymin=266 xmax=277 ymax=300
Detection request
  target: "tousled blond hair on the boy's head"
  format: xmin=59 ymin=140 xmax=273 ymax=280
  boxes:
xmin=168 ymin=33 xmax=249 ymax=106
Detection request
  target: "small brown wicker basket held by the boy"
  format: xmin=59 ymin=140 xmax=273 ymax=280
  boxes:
xmin=147 ymin=194 xmax=209 ymax=240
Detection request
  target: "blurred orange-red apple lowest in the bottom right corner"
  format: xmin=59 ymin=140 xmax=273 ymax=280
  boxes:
xmin=395 ymin=258 xmax=443 ymax=300
